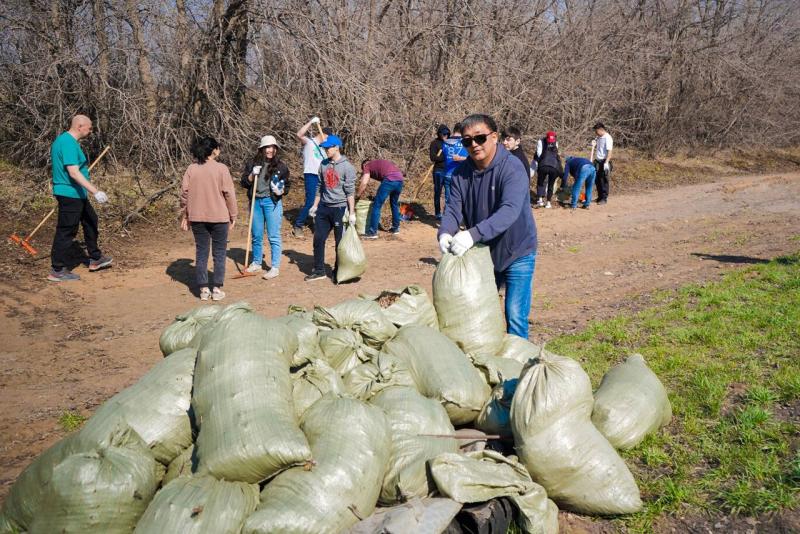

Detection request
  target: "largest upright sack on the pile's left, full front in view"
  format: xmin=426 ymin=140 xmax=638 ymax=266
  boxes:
xmin=192 ymin=304 xmax=311 ymax=483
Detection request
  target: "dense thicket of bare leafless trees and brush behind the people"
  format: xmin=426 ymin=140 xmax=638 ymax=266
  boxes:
xmin=0 ymin=0 xmax=800 ymax=199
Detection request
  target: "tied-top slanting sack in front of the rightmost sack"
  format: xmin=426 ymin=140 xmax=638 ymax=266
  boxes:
xmin=511 ymin=350 xmax=642 ymax=515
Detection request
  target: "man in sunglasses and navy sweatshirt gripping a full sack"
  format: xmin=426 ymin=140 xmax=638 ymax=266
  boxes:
xmin=437 ymin=115 xmax=537 ymax=339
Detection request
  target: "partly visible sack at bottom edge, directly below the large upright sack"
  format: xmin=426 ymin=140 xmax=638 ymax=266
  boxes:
xmin=134 ymin=477 xmax=258 ymax=534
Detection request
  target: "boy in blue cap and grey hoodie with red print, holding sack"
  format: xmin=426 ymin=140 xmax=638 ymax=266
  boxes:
xmin=305 ymin=135 xmax=356 ymax=282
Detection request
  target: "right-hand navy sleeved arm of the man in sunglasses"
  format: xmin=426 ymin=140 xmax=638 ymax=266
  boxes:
xmin=468 ymin=158 xmax=529 ymax=243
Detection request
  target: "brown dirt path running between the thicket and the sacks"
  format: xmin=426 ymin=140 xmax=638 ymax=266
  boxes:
xmin=0 ymin=173 xmax=800 ymax=498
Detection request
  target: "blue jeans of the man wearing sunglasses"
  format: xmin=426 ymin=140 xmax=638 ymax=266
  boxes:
xmin=494 ymin=252 xmax=536 ymax=339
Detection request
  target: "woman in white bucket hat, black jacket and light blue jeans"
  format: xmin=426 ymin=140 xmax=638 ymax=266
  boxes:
xmin=241 ymin=135 xmax=289 ymax=280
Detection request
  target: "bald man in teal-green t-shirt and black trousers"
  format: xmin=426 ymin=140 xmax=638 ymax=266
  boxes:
xmin=47 ymin=115 xmax=113 ymax=282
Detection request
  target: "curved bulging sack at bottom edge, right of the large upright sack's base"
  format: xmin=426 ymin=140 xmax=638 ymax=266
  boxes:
xmin=242 ymin=395 xmax=391 ymax=534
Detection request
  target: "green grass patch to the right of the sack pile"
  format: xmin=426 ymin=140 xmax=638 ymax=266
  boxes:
xmin=548 ymin=254 xmax=800 ymax=532
